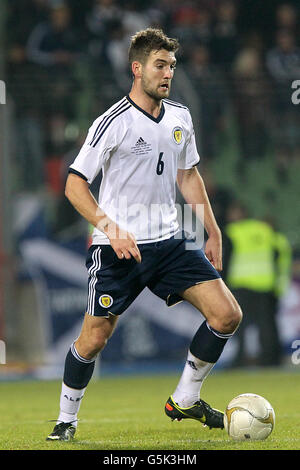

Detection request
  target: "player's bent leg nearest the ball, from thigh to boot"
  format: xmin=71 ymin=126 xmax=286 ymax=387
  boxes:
xmin=166 ymin=279 xmax=242 ymax=427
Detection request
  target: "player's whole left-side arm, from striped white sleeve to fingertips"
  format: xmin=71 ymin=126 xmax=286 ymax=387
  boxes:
xmin=65 ymin=103 xmax=141 ymax=262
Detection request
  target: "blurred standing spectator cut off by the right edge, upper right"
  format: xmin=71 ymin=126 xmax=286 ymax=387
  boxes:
xmin=266 ymin=29 xmax=300 ymax=170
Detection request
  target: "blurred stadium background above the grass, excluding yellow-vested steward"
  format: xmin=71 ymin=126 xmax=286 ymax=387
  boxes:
xmin=0 ymin=0 xmax=300 ymax=380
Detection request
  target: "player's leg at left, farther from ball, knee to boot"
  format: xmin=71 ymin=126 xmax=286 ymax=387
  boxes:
xmin=47 ymin=314 xmax=117 ymax=440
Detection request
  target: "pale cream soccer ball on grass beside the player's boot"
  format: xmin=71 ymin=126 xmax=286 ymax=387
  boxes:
xmin=224 ymin=393 xmax=275 ymax=441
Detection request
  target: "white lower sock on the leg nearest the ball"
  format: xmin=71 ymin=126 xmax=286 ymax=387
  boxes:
xmin=172 ymin=351 xmax=215 ymax=408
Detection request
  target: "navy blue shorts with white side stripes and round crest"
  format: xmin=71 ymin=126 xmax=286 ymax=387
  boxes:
xmin=86 ymin=230 xmax=220 ymax=317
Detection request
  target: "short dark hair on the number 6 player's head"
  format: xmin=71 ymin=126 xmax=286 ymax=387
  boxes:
xmin=128 ymin=28 xmax=179 ymax=64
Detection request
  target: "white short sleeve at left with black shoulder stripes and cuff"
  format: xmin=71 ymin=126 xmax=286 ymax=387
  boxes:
xmin=69 ymin=116 xmax=117 ymax=184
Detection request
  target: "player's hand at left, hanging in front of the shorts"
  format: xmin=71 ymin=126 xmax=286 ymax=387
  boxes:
xmin=106 ymin=224 xmax=142 ymax=263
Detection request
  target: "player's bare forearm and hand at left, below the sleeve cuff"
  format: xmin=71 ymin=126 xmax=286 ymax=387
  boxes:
xmin=65 ymin=173 xmax=141 ymax=263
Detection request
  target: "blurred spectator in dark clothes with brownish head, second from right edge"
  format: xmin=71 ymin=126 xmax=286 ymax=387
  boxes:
xmin=232 ymin=48 xmax=272 ymax=174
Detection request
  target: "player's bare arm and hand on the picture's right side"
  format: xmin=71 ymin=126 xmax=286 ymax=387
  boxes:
xmin=177 ymin=166 xmax=222 ymax=271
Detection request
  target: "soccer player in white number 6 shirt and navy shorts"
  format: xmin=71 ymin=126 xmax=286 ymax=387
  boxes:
xmin=47 ymin=28 xmax=241 ymax=441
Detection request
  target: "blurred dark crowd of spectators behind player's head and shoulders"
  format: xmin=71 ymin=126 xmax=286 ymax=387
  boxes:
xmin=6 ymin=0 xmax=300 ymax=242
